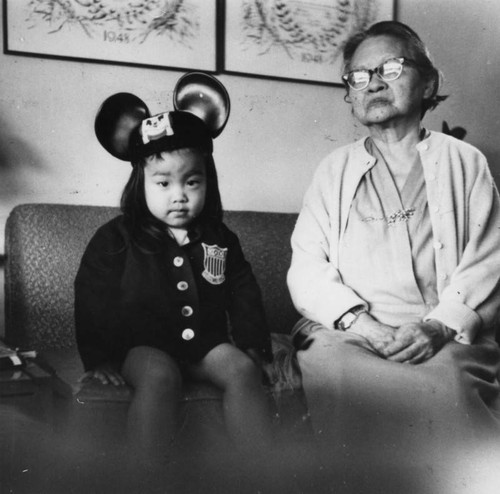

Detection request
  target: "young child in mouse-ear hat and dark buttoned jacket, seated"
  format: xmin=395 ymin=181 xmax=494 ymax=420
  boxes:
xmin=75 ymin=73 xmax=272 ymax=464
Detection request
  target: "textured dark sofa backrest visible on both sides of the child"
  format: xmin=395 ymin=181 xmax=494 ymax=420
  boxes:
xmin=5 ymin=204 xmax=298 ymax=350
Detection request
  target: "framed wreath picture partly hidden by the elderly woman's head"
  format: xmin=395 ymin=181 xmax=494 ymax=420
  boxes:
xmin=224 ymin=0 xmax=395 ymax=85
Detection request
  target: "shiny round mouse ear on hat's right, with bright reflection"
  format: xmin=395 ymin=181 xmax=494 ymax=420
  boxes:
xmin=174 ymin=72 xmax=231 ymax=138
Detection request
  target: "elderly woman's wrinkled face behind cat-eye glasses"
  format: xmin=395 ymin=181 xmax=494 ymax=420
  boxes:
xmin=348 ymin=35 xmax=433 ymax=128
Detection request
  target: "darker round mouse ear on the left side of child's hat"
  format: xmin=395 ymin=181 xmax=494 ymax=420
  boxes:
xmin=94 ymin=93 xmax=150 ymax=161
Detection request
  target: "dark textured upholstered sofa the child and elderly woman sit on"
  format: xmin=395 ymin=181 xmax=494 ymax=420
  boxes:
xmin=5 ymin=204 xmax=307 ymax=436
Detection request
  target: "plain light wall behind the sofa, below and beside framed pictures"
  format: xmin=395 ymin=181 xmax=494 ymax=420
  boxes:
xmin=0 ymin=0 xmax=500 ymax=336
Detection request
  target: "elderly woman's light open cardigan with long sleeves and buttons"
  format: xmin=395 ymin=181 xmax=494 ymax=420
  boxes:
xmin=288 ymin=132 xmax=500 ymax=343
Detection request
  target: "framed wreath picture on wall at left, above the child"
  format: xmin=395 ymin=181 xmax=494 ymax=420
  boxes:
xmin=3 ymin=0 xmax=217 ymax=72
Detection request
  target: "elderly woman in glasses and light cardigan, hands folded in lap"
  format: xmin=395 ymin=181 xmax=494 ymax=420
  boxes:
xmin=288 ymin=21 xmax=500 ymax=492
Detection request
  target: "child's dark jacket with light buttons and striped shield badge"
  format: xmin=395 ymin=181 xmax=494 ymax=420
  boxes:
xmin=75 ymin=216 xmax=271 ymax=370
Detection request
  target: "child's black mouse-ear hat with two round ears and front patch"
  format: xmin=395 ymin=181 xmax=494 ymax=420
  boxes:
xmin=95 ymin=72 xmax=230 ymax=161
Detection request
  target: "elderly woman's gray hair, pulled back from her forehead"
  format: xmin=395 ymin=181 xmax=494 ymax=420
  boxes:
xmin=343 ymin=21 xmax=448 ymax=117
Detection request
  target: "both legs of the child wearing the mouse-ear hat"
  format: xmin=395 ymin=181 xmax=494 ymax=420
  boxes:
xmin=122 ymin=343 xmax=272 ymax=464
